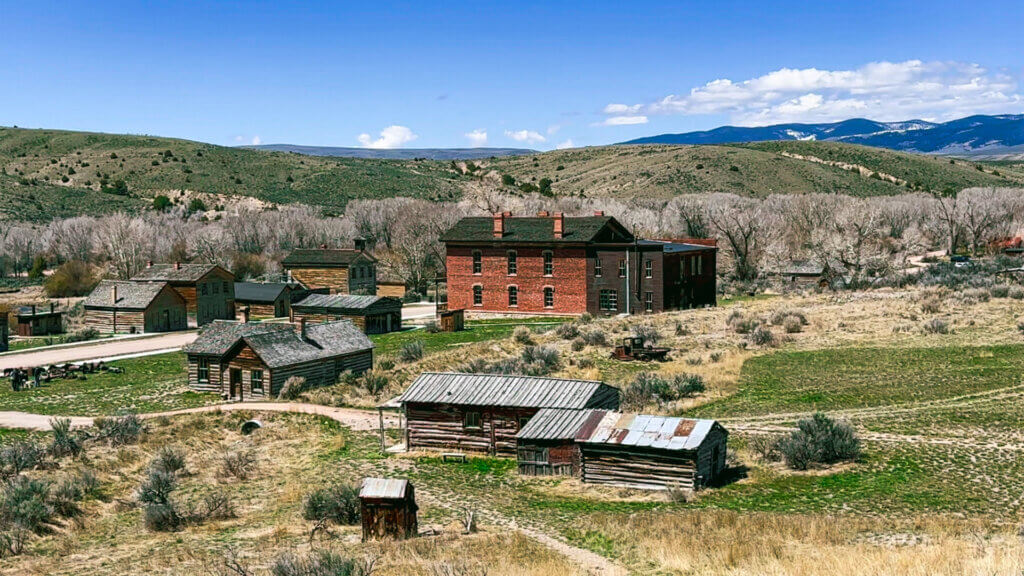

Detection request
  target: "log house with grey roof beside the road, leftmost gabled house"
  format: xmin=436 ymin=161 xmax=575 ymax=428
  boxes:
xmin=85 ymin=280 xmax=188 ymax=334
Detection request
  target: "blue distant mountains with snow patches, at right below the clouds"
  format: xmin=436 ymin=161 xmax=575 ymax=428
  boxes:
xmin=621 ymin=114 xmax=1024 ymax=159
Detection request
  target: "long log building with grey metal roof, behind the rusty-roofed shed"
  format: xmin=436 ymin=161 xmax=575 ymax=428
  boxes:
xmin=397 ymin=372 xmax=620 ymax=456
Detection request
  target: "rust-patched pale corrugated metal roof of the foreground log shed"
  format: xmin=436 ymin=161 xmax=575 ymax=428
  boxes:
xmin=577 ymin=412 xmax=720 ymax=450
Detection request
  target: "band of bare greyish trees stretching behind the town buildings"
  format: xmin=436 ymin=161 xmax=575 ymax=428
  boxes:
xmin=0 ymin=189 xmax=1024 ymax=291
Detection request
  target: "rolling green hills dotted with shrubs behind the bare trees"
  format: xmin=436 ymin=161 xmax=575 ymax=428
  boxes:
xmin=0 ymin=128 xmax=1024 ymax=220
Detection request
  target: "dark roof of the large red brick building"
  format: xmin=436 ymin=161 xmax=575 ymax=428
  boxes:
xmin=440 ymin=216 xmax=633 ymax=244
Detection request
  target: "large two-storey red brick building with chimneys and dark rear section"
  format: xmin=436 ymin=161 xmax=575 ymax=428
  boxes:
xmin=441 ymin=212 xmax=718 ymax=315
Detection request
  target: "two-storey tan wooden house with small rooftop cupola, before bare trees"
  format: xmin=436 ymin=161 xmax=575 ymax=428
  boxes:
xmin=281 ymin=241 xmax=377 ymax=294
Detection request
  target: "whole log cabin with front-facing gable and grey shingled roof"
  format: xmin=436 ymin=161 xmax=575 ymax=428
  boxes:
xmin=183 ymin=313 xmax=374 ymax=400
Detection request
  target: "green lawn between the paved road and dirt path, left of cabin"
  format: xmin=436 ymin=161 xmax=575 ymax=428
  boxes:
xmin=0 ymin=353 xmax=214 ymax=416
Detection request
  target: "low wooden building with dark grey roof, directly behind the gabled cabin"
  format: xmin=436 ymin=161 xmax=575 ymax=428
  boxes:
xmin=292 ymin=294 xmax=401 ymax=334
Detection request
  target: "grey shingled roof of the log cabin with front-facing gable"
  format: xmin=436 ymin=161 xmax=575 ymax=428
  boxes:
xmin=183 ymin=320 xmax=374 ymax=368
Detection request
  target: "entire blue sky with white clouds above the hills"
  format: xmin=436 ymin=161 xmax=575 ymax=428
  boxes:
xmin=0 ymin=0 xmax=1024 ymax=150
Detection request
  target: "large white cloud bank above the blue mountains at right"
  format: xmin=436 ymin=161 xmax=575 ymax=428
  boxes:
xmin=604 ymin=60 xmax=1024 ymax=125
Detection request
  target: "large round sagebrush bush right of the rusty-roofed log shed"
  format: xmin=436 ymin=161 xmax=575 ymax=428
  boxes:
xmin=778 ymin=412 xmax=860 ymax=470
